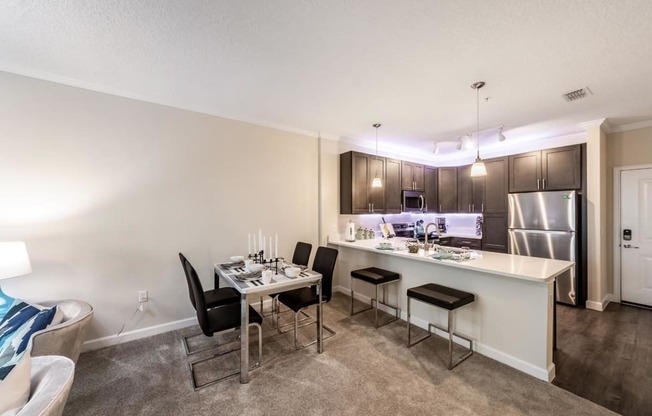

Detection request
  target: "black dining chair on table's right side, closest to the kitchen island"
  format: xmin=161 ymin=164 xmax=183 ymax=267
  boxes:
xmin=277 ymin=247 xmax=338 ymax=349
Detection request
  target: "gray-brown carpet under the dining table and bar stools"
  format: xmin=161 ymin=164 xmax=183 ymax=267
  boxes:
xmin=64 ymin=294 xmax=614 ymax=416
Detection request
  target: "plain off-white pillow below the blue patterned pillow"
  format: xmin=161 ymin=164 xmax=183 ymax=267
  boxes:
xmin=0 ymin=352 xmax=32 ymax=416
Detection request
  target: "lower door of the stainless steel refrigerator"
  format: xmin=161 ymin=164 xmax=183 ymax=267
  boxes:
xmin=508 ymin=230 xmax=577 ymax=305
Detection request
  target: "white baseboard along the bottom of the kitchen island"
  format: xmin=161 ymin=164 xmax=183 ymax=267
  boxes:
xmin=333 ymin=286 xmax=556 ymax=382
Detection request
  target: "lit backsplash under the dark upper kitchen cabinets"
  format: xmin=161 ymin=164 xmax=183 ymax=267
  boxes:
xmin=337 ymin=213 xmax=482 ymax=236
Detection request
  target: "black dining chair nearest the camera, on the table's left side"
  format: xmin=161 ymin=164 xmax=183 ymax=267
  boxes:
xmin=186 ymin=263 xmax=263 ymax=390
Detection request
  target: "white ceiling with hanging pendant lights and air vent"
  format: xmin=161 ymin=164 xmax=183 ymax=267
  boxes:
xmin=0 ymin=0 xmax=652 ymax=164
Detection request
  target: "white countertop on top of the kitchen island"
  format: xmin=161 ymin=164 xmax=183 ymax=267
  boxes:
xmin=328 ymin=237 xmax=575 ymax=283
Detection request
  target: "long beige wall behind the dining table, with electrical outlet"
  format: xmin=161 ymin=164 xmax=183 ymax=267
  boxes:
xmin=0 ymin=72 xmax=320 ymax=342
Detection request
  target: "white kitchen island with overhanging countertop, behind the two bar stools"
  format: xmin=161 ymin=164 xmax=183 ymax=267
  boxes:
xmin=328 ymin=237 xmax=574 ymax=382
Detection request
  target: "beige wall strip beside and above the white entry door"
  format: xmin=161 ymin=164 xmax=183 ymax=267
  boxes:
xmin=606 ymin=127 xmax=652 ymax=293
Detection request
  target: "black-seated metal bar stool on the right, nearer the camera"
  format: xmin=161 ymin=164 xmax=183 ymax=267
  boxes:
xmin=407 ymin=283 xmax=475 ymax=370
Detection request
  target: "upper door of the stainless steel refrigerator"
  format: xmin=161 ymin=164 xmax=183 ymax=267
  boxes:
xmin=507 ymin=191 xmax=577 ymax=231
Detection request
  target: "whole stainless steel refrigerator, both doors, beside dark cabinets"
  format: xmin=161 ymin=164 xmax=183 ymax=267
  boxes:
xmin=508 ymin=191 xmax=579 ymax=305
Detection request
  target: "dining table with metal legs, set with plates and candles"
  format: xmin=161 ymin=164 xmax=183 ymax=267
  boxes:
xmin=214 ymin=262 xmax=324 ymax=384
